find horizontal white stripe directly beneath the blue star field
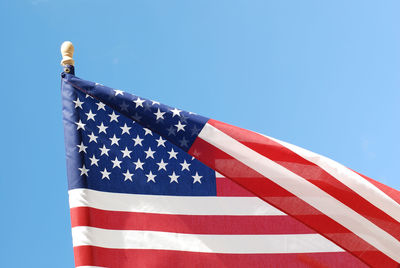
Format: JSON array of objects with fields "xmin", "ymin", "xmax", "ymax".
[{"xmin": 68, "ymin": 189, "xmax": 286, "ymax": 216}]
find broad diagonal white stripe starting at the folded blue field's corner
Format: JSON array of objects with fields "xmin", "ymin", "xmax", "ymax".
[{"xmin": 199, "ymin": 124, "xmax": 400, "ymax": 262}]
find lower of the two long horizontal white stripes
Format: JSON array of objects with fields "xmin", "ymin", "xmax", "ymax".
[{"xmin": 72, "ymin": 226, "xmax": 343, "ymax": 254}]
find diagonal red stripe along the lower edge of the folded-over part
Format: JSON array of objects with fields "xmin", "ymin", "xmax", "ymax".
[{"xmin": 189, "ymin": 133, "xmax": 398, "ymax": 267}]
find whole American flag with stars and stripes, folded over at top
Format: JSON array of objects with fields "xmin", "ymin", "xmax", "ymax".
[{"xmin": 62, "ymin": 66, "xmax": 400, "ymax": 267}]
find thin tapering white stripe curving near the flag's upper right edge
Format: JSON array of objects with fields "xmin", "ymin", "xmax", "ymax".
[{"xmin": 268, "ymin": 137, "xmax": 400, "ymax": 222}]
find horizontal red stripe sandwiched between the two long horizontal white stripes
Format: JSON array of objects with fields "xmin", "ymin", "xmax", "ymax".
[{"xmin": 70, "ymin": 207, "xmax": 315, "ymax": 235}]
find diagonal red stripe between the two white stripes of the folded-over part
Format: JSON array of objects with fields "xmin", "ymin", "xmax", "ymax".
[{"xmin": 209, "ymin": 120, "xmax": 400, "ymax": 241}]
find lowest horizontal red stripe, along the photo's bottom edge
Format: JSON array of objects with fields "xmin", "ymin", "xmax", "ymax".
[{"xmin": 74, "ymin": 246, "xmax": 366, "ymax": 268}]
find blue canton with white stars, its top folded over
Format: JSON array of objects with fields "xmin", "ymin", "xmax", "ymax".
[{"xmin": 62, "ymin": 71, "xmax": 216, "ymax": 196}]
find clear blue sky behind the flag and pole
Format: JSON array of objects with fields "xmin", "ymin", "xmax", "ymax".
[{"xmin": 0, "ymin": 0, "xmax": 400, "ymax": 268}]
